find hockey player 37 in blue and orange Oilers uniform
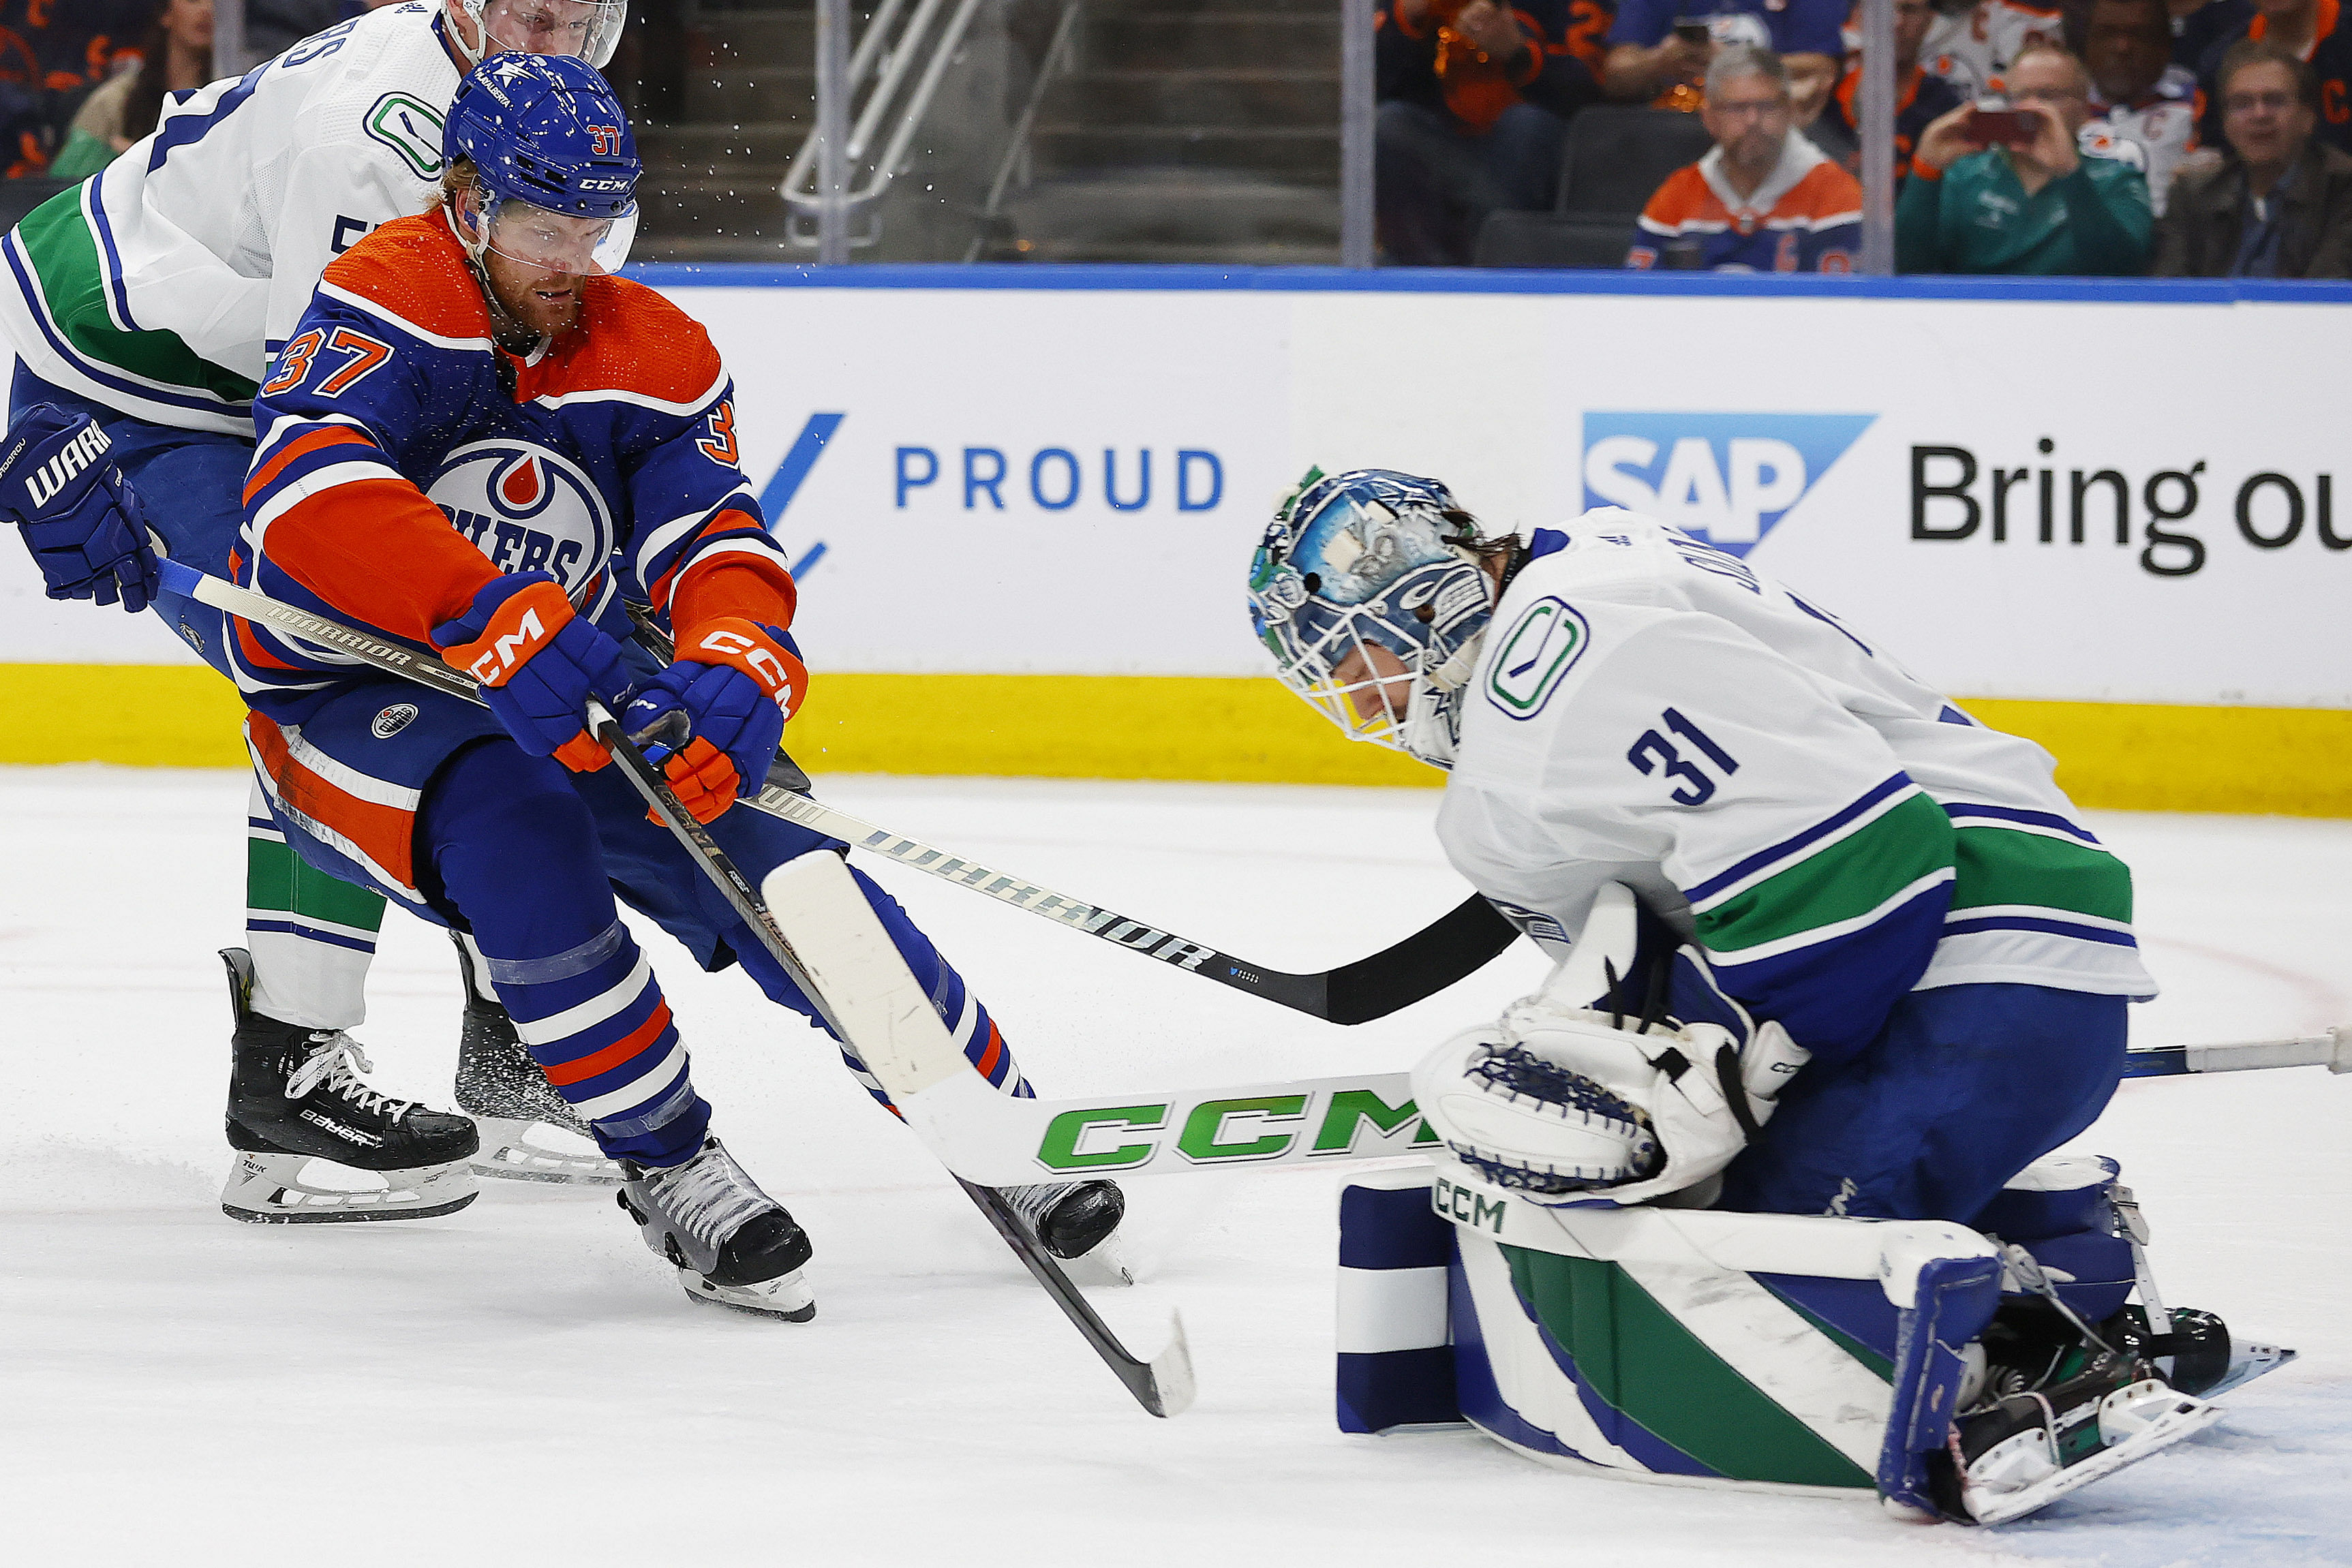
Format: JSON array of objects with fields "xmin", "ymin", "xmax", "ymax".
[{"xmin": 78, "ymin": 57, "xmax": 1122, "ymax": 1319}]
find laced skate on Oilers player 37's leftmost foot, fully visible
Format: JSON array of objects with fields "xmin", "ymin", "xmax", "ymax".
[{"xmin": 614, "ymin": 1138, "xmax": 816, "ymax": 1323}]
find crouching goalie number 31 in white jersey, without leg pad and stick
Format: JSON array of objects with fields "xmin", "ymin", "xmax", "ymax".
[{"xmin": 1249, "ymin": 470, "xmax": 2257, "ymax": 1519}]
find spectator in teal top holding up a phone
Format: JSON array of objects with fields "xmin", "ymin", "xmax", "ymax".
[{"xmin": 1896, "ymin": 45, "xmax": 2154, "ymax": 277}]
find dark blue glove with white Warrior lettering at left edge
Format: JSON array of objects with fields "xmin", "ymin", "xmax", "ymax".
[{"xmin": 0, "ymin": 402, "xmax": 155, "ymax": 613}]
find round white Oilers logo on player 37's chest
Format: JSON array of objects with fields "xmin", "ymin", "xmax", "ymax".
[{"xmin": 423, "ymin": 440, "xmax": 614, "ymax": 604}]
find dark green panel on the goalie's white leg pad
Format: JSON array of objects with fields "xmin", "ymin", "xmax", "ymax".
[{"xmin": 1501, "ymin": 1246, "xmax": 1872, "ymax": 1488}]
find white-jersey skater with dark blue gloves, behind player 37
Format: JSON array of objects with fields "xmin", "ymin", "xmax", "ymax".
[{"xmin": 0, "ymin": 0, "xmax": 626, "ymax": 1220}]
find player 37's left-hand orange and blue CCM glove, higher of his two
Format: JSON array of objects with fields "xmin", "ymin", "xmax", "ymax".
[{"xmin": 433, "ymin": 571, "xmax": 628, "ymax": 773}]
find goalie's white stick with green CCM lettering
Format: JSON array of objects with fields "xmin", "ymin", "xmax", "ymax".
[{"xmin": 885, "ymin": 1025, "xmax": 2352, "ymax": 1185}]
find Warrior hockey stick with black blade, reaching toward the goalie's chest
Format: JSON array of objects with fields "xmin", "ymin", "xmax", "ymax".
[{"xmin": 160, "ymin": 559, "xmax": 1519, "ymax": 1023}]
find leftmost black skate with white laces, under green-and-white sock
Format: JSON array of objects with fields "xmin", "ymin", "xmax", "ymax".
[{"xmin": 221, "ymin": 947, "xmax": 480, "ymax": 1225}]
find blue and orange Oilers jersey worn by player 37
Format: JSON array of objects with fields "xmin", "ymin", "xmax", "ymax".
[{"xmin": 233, "ymin": 211, "xmax": 793, "ymax": 722}]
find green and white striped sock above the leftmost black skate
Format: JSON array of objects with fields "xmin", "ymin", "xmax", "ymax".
[{"xmin": 245, "ymin": 783, "xmax": 384, "ymax": 1030}]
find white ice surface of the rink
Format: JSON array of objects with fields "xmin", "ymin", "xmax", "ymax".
[{"xmin": 0, "ymin": 769, "xmax": 2352, "ymax": 1568}]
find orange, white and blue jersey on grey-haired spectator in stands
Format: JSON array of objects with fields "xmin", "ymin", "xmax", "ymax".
[{"xmin": 1625, "ymin": 132, "xmax": 1863, "ymax": 273}]
